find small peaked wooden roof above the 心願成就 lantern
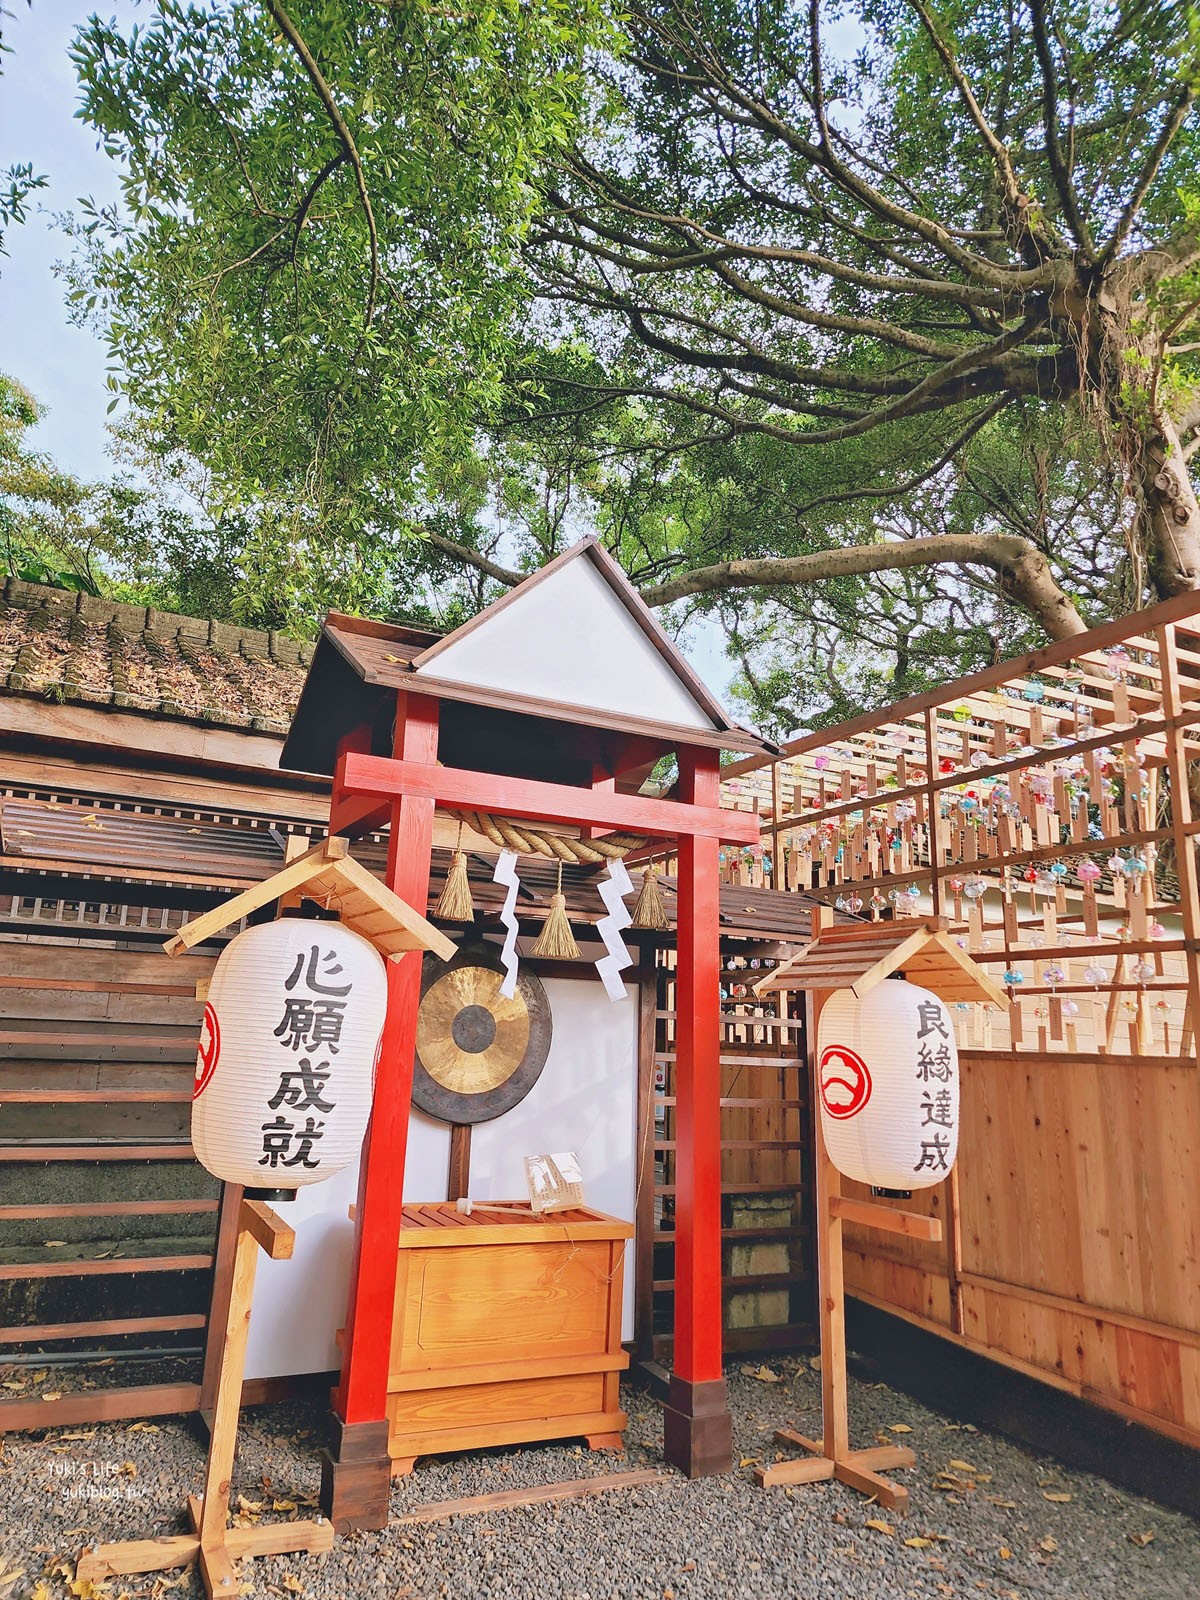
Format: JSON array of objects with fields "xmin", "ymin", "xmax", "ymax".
[{"xmin": 163, "ymin": 838, "xmax": 456, "ymax": 962}]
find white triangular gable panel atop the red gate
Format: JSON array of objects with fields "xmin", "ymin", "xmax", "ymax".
[{"xmin": 414, "ymin": 557, "xmax": 715, "ymax": 731}]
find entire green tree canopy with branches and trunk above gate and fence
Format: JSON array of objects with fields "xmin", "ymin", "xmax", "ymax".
[{"xmin": 49, "ymin": 0, "xmax": 1200, "ymax": 720}]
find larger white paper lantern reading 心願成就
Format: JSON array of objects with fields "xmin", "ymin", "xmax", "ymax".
[{"xmin": 192, "ymin": 917, "xmax": 387, "ymax": 1189}]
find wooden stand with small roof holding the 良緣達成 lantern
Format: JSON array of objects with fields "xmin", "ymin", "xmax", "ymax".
[{"xmin": 754, "ymin": 906, "xmax": 1006, "ymax": 1515}]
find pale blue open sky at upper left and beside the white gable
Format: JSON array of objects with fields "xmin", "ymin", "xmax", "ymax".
[{"xmin": 0, "ymin": 0, "xmax": 733, "ymax": 694}]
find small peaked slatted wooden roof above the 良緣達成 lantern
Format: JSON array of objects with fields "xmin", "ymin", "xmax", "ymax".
[{"xmin": 752, "ymin": 917, "xmax": 1008, "ymax": 1006}]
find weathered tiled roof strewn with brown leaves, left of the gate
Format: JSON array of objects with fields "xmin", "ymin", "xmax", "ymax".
[{"xmin": 0, "ymin": 578, "xmax": 312, "ymax": 734}]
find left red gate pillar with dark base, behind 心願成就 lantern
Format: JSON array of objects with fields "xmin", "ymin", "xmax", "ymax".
[{"xmin": 322, "ymin": 693, "xmax": 438, "ymax": 1531}]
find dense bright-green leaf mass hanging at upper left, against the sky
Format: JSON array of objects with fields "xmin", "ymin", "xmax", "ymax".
[{"xmin": 61, "ymin": 0, "xmax": 614, "ymax": 614}]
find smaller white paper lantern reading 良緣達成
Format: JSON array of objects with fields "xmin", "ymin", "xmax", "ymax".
[{"xmin": 818, "ymin": 978, "xmax": 958, "ymax": 1189}]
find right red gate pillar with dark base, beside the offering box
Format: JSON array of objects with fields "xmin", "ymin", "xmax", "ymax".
[{"xmin": 664, "ymin": 749, "xmax": 733, "ymax": 1478}]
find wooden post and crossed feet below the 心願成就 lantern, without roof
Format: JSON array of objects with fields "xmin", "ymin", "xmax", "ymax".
[{"xmin": 75, "ymin": 1200, "xmax": 333, "ymax": 1600}]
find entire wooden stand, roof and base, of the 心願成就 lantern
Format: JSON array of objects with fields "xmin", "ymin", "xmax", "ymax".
[{"xmin": 75, "ymin": 838, "xmax": 454, "ymax": 1580}]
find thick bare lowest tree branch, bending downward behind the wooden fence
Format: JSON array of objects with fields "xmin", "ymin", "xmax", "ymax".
[{"xmin": 642, "ymin": 533, "xmax": 1086, "ymax": 638}]
